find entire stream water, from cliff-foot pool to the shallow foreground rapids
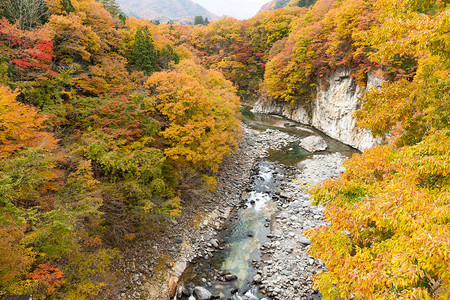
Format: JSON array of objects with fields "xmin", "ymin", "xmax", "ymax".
[{"xmin": 181, "ymin": 111, "xmax": 356, "ymax": 300}]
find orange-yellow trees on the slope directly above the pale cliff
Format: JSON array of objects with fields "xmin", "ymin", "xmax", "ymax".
[{"xmin": 264, "ymin": 0, "xmax": 376, "ymax": 101}]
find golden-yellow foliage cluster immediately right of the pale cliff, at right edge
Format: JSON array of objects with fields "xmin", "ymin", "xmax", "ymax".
[{"xmin": 355, "ymin": 77, "xmax": 444, "ymax": 146}]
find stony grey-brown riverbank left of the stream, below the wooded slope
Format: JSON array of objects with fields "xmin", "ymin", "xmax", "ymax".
[{"xmin": 110, "ymin": 124, "xmax": 304, "ymax": 299}]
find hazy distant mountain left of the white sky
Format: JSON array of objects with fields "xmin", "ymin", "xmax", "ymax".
[{"xmin": 117, "ymin": 0, "xmax": 217, "ymax": 23}]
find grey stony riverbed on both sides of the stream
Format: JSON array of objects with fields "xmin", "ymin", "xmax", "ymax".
[{"xmin": 113, "ymin": 113, "xmax": 352, "ymax": 300}]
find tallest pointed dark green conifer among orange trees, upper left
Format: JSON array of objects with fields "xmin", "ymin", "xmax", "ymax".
[{"xmin": 131, "ymin": 27, "xmax": 158, "ymax": 74}]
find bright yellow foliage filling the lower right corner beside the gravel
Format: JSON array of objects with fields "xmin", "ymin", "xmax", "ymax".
[{"xmin": 308, "ymin": 124, "xmax": 450, "ymax": 299}]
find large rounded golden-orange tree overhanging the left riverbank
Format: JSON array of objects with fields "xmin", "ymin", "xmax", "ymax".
[{"xmin": 147, "ymin": 61, "xmax": 239, "ymax": 171}]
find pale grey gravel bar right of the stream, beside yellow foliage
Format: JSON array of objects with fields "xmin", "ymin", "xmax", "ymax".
[{"xmin": 254, "ymin": 153, "xmax": 345, "ymax": 299}]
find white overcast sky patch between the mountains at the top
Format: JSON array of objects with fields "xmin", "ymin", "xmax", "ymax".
[{"xmin": 193, "ymin": 0, "xmax": 270, "ymax": 19}]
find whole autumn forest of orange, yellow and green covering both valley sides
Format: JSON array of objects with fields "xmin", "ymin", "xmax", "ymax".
[{"xmin": 0, "ymin": 0, "xmax": 450, "ymax": 299}]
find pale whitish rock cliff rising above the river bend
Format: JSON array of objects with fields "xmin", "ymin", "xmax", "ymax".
[{"xmin": 253, "ymin": 69, "xmax": 382, "ymax": 150}]
